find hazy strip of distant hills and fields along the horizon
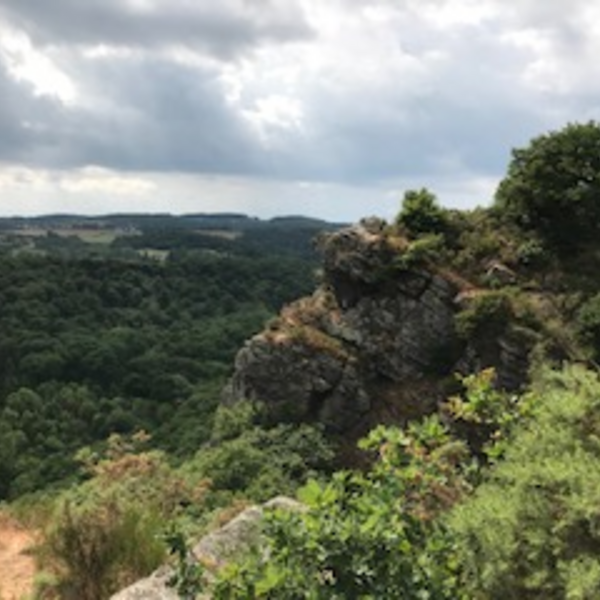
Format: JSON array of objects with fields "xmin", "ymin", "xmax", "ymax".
[{"xmin": 0, "ymin": 213, "xmax": 343, "ymax": 260}]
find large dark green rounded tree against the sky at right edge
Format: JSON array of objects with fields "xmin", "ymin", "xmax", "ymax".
[{"xmin": 496, "ymin": 121, "xmax": 600, "ymax": 249}]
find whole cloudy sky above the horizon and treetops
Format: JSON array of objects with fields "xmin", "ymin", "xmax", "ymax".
[{"xmin": 0, "ymin": 0, "xmax": 600, "ymax": 221}]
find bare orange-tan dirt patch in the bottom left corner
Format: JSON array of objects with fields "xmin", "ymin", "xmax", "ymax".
[{"xmin": 0, "ymin": 515, "xmax": 35, "ymax": 600}]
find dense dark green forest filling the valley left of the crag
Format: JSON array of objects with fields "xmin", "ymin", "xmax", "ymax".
[{"xmin": 0, "ymin": 217, "xmax": 332, "ymax": 498}]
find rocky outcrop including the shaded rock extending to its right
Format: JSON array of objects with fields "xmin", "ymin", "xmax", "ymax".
[{"xmin": 223, "ymin": 221, "xmax": 529, "ymax": 435}]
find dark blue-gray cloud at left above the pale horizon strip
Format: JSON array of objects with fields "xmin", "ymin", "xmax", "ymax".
[{"xmin": 0, "ymin": 41, "xmax": 268, "ymax": 173}]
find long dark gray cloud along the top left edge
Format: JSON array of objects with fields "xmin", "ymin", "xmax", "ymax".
[{"xmin": 0, "ymin": 0, "xmax": 312, "ymax": 58}]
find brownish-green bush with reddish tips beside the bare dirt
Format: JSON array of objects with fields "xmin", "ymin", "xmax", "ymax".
[{"xmin": 39, "ymin": 434, "xmax": 205, "ymax": 600}]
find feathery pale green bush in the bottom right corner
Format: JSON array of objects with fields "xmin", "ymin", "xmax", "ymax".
[{"xmin": 449, "ymin": 367, "xmax": 600, "ymax": 600}]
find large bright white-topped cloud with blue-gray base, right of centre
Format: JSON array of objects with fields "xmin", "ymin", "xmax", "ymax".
[{"xmin": 220, "ymin": 2, "xmax": 543, "ymax": 183}]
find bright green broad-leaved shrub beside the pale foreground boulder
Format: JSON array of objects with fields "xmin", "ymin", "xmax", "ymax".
[{"xmin": 212, "ymin": 419, "xmax": 464, "ymax": 600}]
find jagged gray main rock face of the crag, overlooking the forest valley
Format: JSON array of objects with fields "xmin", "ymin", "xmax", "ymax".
[{"xmin": 224, "ymin": 226, "xmax": 457, "ymax": 433}]
